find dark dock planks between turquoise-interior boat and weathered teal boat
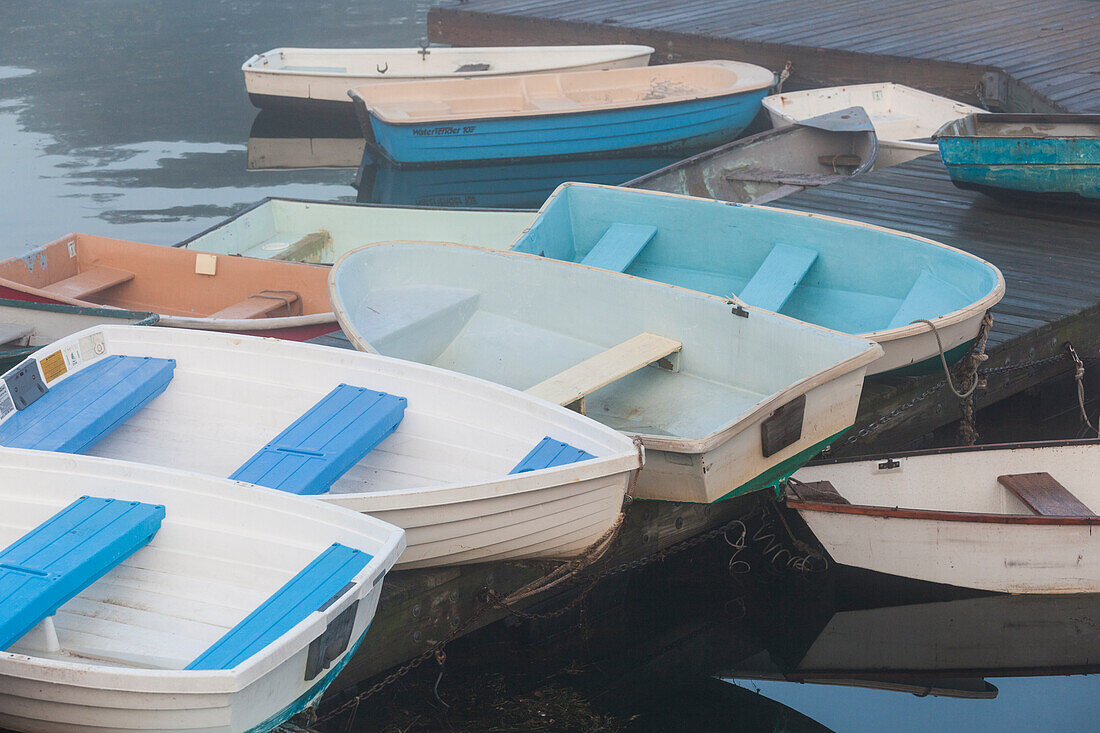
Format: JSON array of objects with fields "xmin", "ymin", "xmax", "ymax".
[{"xmin": 772, "ymin": 155, "xmax": 1100, "ymax": 453}]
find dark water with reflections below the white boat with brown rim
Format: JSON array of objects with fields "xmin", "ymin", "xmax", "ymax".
[{"xmin": 321, "ymin": 515, "xmax": 1100, "ymax": 732}]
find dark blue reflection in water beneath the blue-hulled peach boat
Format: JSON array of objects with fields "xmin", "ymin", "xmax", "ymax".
[{"xmin": 355, "ymin": 149, "xmax": 674, "ymax": 209}]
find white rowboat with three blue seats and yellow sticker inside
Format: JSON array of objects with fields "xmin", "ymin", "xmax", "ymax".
[{"xmin": 0, "ymin": 327, "xmax": 642, "ymax": 568}]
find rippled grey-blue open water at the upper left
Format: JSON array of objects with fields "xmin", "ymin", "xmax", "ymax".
[{"xmin": 0, "ymin": 0, "xmax": 431, "ymax": 256}]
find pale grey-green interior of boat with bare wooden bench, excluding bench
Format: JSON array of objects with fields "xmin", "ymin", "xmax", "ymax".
[{"xmin": 330, "ymin": 242, "xmax": 880, "ymax": 442}]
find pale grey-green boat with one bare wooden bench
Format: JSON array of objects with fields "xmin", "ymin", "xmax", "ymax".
[{"xmin": 330, "ymin": 242, "xmax": 881, "ymax": 502}]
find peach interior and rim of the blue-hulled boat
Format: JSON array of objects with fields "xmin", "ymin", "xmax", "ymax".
[{"xmin": 354, "ymin": 61, "xmax": 774, "ymax": 123}]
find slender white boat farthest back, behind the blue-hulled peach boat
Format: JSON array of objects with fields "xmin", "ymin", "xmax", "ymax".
[{"xmin": 241, "ymin": 45, "xmax": 653, "ymax": 109}]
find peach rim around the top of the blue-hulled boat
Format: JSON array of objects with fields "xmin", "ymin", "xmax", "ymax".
[{"xmin": 348, "ymin": 59, "xmax": 776, "ymax": 125}]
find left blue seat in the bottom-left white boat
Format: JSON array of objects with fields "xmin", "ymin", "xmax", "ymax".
[{"xmin": 0, "ymin": 496, "xmax": 164, "ymax": 649}]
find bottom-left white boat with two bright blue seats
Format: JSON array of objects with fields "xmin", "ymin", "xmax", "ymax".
[{"xmin": 0, "ymin": 449, "xmax": 405, "ymax": 733}]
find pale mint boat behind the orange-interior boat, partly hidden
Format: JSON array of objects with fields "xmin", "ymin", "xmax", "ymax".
[{"xmin": 176, "ymin": 198, "xmax": 535, "ymax": 264}]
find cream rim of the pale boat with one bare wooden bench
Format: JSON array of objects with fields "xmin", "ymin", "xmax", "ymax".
[{"xmin": 329, "ymin": 239, "xmax": 883, "ymax": 453}]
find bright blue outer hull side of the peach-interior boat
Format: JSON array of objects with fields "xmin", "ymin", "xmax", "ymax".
[{"xmin": 358, "ymin": 89, "xmax": 768, "ymax": 164}]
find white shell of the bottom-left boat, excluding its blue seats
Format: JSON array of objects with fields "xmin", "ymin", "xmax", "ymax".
[{"xmin": 0, "ymin": 449, "xmax": 405, "ymax": 733}]
